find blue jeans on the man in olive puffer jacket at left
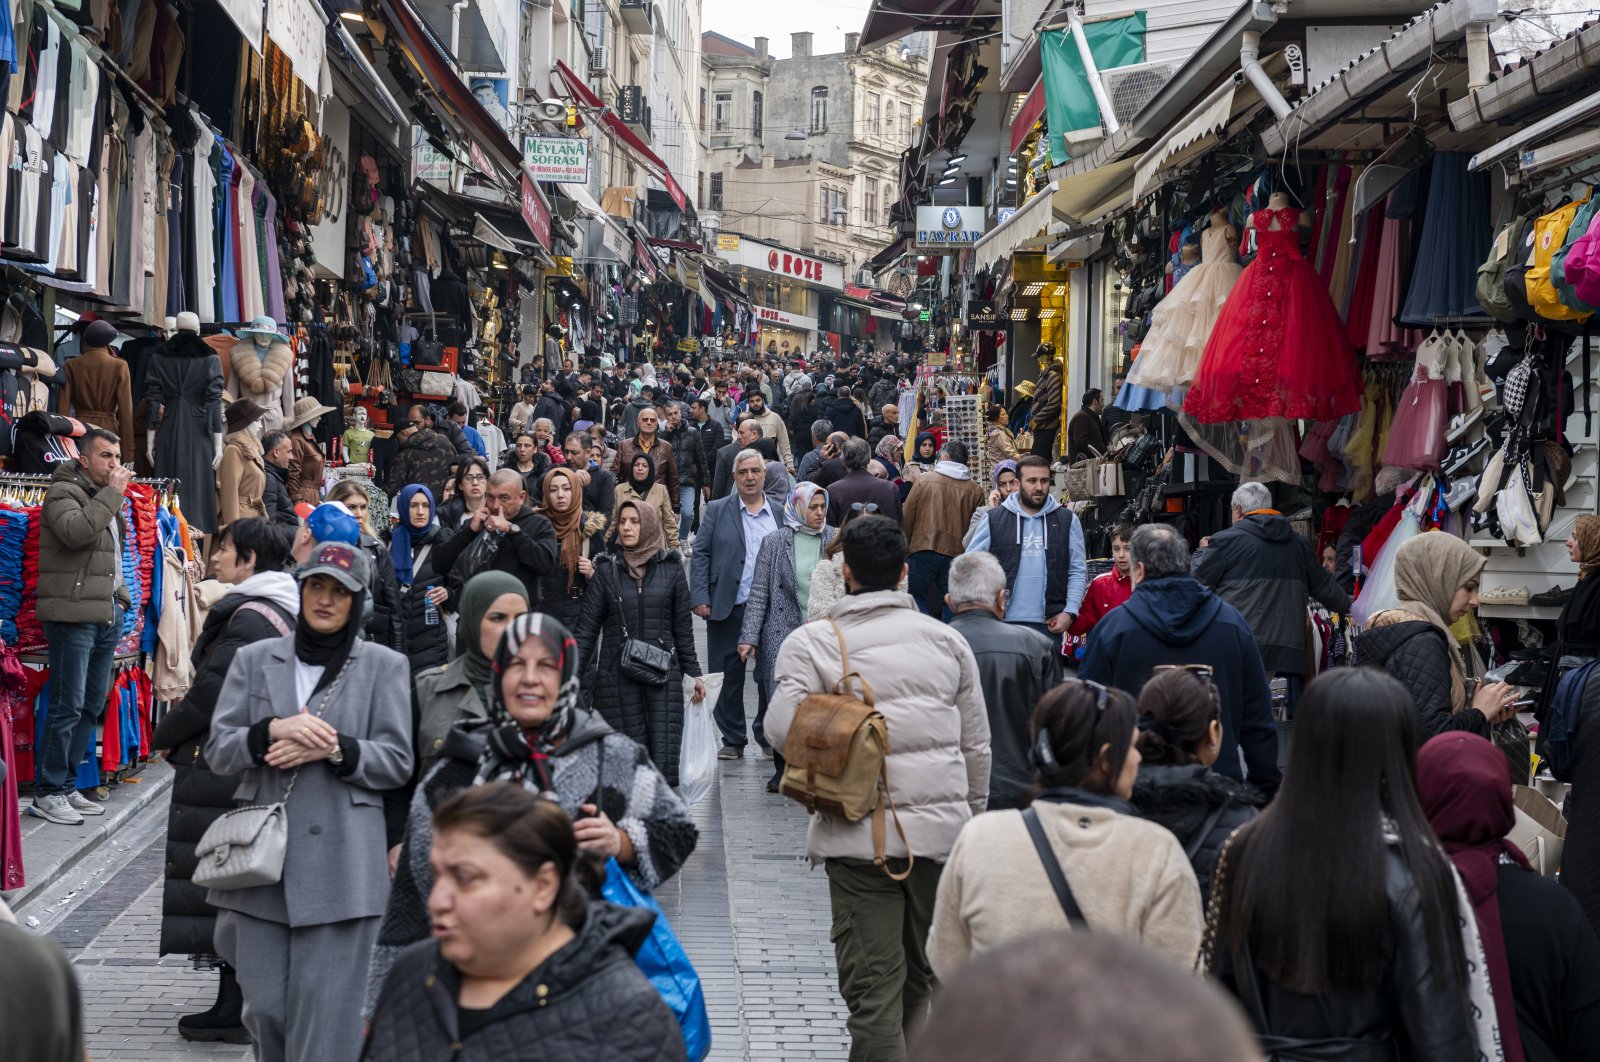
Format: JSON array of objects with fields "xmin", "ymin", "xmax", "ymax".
[{"xmin": 35, "ymin": 608, "xmax": 122, "ymax": 797}]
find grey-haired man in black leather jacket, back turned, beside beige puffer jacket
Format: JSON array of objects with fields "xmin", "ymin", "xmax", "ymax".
[{"xmin": 944, "ymin": 553, "xmax": 1061, "ymax": 811}]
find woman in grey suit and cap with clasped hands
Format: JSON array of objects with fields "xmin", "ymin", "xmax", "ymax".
[{"xmin": 205, "ymin": 542, "xmax": 413, "ymax": 1062}]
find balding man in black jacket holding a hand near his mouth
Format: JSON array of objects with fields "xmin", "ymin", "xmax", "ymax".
[{"xmin": 430, "ymin": 469, "xmax": 560, "ymax": 609}]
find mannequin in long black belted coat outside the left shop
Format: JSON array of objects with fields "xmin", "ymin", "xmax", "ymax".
[{"xmin": 142, "ymin": 312, "xmax": 222, "ymax": 534}]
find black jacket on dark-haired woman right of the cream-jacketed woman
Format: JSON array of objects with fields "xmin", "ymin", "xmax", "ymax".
[{"xmin": 1133, "ymin": 763, "xmax": 1262, "ymax": 904}]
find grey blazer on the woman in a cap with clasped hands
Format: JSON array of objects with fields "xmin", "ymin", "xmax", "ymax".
[{"xmin": 205, "ymin": 635, "xmax": 413, "ymax": 926}]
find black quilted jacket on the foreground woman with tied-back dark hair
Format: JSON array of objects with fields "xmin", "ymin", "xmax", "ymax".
[{"xmin": 362, "ymin": 902, "xmax": 685, "ymax": 1062}]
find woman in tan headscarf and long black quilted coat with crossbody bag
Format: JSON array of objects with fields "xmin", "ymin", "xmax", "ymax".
[{"xmin": 578, "ymin": 501, "xmax": 706, "ymax": 785}]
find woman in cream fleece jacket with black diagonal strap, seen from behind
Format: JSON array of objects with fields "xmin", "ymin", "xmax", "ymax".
[{"xmin": 928, "ymin": 680, "xmax": 1202, "ymax": 979}]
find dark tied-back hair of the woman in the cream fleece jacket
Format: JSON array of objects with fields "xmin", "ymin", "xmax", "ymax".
[{"xmin": 1030, "ymin": 680, "xmax": 1138, "ymax": 795}]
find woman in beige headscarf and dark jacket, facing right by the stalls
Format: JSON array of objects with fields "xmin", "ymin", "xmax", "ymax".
[{"xmin": 1357, "ymin": 531, "xmax": 1517, "ymax": 737}]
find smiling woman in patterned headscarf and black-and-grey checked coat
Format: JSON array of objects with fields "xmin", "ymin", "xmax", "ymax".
[{"xmin": 371, "ymin": 614, "xmax": 698, "ymax": 1010}]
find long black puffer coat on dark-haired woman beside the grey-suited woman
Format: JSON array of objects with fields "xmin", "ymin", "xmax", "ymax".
[{"xmin": 150, "ymin": 576, "xmax": 294, "ymax": 955}]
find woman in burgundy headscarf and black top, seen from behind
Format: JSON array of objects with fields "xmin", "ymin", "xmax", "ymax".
[{"xmin": 1416, "ymin": 733, "xmax": 1600, "ymax": 1062}]
